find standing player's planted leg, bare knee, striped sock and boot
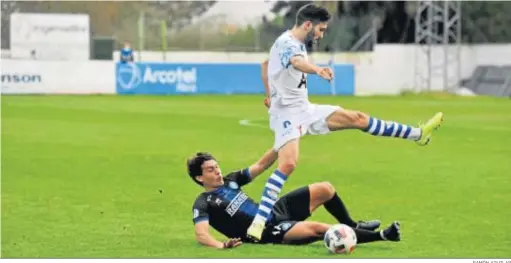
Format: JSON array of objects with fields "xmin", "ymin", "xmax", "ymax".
[{"xmin": 247, "ymin": 139, "xmax": 299, "ymax": 241}]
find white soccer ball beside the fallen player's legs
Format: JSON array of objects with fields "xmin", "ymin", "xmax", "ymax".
[{"xmin": 324, "ymin": 224, "xmax": 357, "ymax": 254}]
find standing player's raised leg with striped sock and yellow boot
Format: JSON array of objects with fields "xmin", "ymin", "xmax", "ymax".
[{"xmin": 327, "ymin": 109, "xmax": 444, "ymax": 145}]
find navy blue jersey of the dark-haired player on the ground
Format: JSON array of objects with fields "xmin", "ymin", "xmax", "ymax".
[{"xmin": 193, "ymin": 169, "xmax": 259, "ymax": 239}]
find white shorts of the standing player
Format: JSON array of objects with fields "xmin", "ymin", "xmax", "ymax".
[{"xmin": 270, "ymin": 104, "xmax": 341, "ymax": 151}]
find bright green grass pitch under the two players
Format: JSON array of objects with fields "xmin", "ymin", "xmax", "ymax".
[{"xmin": 1, "ymin": 96, "xmax": 511, "ymax": 258}]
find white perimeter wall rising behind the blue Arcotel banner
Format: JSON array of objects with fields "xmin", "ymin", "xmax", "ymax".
[{"xmin": 114, "ymin": 44, "xmax": 511, "ymax": 95}]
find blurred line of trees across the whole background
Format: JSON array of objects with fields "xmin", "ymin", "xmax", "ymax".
[{"xmin": 1, "ymin": 1, "xmax": 511, "ymax": 51}]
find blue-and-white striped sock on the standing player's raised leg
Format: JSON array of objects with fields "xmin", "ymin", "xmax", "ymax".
[{"xmin": 364, "ymin": 117, "xmax": 421, "ymax": 141}]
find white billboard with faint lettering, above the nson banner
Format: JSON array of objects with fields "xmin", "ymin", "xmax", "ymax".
[{"xmin": 10, "ymin": 13, "xmax": 90, "ymax": 60}]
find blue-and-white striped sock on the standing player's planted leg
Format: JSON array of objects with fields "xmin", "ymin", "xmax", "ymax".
[{"xmin": 254, "ymin": 170, "xmax": 287, "ymax": 224}]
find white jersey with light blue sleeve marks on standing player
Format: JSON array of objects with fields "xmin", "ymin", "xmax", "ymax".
[{"xmin": 268, "ymin": 31, "xmax": 309, "ymax": 115}]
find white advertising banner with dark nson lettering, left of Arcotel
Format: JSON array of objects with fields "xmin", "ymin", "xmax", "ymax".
[{"xmin": 1, "ymin": 59, "xmax": 115, "ymax": 94}]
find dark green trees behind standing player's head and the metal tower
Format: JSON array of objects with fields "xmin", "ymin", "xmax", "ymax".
[{"xmin": 262, "ymin": 1, "xmax": 511, "ymax": 51}]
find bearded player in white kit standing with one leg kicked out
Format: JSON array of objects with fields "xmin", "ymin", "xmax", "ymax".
[{"xmin": 247, "ymin": 4, "xmax": 443, "ymax": 243}]
